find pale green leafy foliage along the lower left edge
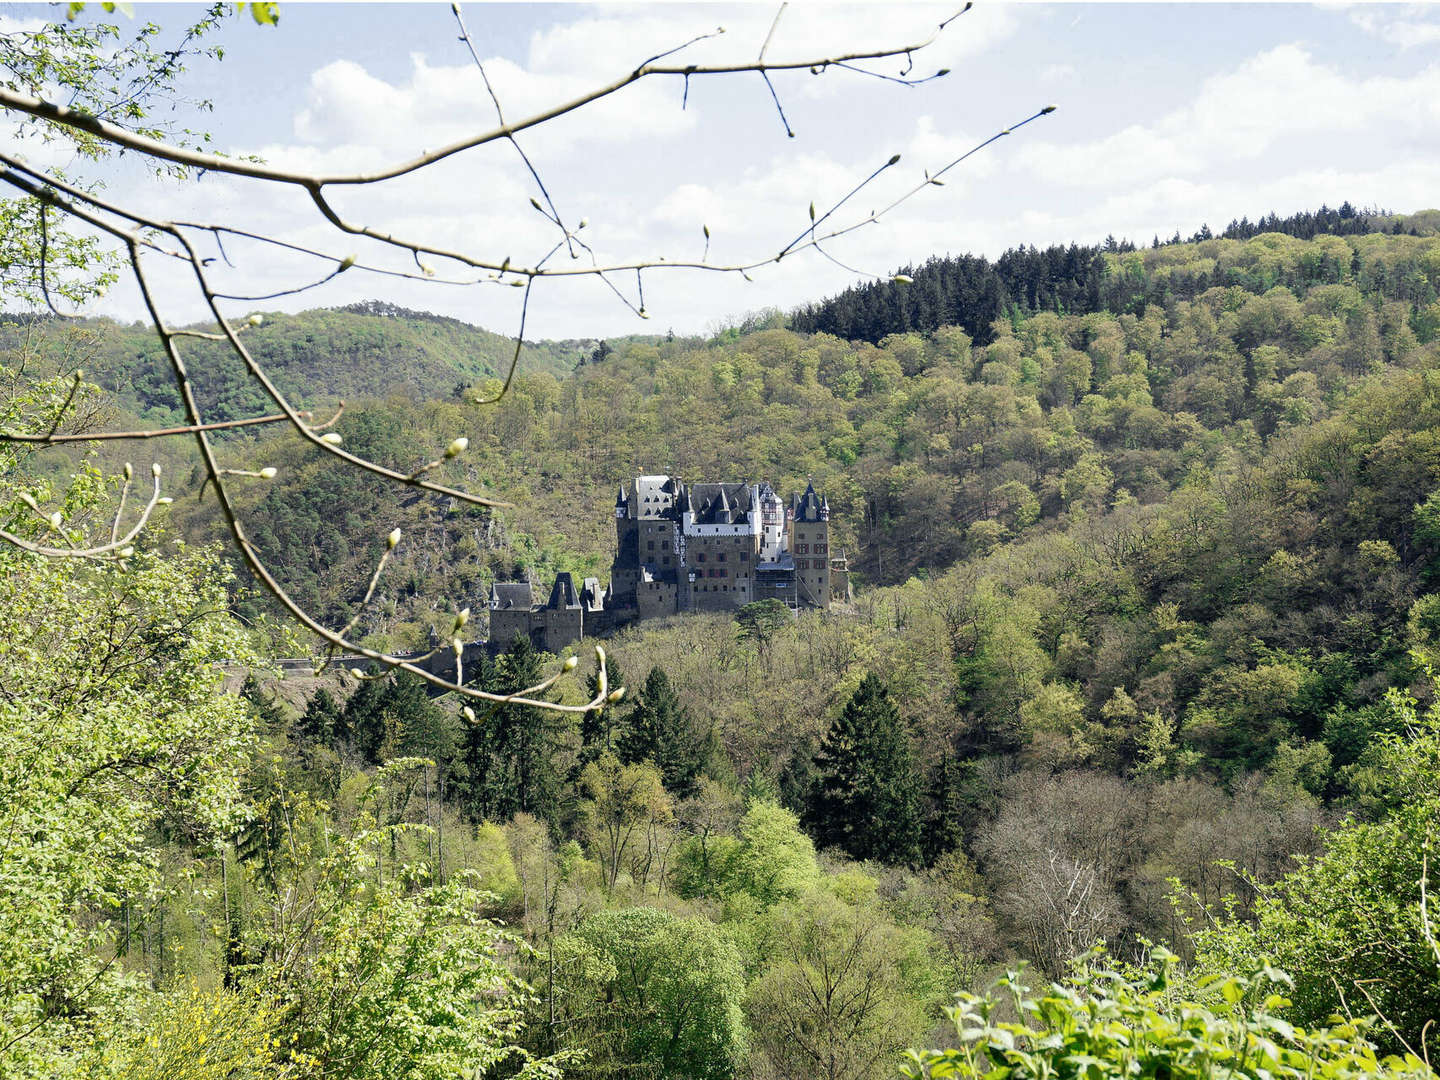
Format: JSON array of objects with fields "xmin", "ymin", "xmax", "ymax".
[{"xmin": 0, "ymin": 552, "xmax": 255, "ymax": 1073}]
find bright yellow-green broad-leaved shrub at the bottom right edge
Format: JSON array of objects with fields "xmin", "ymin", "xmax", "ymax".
[{"xmin": 903, "ymin": 950, "xmax": 1433, "ymax": 1080}]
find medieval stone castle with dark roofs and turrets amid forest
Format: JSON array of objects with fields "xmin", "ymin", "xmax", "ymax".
[{"xmin": 490, "ymin": 475, "xmax": 851, "ymax": 652}]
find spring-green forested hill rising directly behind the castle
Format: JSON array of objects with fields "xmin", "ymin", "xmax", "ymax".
[{"xmin": 95, "ymin": 223, "xmax": 1440, "ymax": 647}]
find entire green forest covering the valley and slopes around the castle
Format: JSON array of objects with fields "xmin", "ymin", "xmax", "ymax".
[{"xmin": 0, "ymin": 194, "xmax": 1440, "ymax": 1080}]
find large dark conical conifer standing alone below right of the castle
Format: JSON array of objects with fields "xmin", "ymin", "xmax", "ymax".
[{"xmin": 806, "ymin": 675, "xmax": 920, "ymax": 863}]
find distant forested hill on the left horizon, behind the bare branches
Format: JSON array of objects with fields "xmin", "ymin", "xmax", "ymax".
[{"xmin": 0, "ymin": 301, "xmax": 595, "ymax": 425}]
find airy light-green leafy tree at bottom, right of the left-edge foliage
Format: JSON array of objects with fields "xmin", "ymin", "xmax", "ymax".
[{"xmin": 243, "ymin": 759, "xmax": 559, "ymax": 1080}]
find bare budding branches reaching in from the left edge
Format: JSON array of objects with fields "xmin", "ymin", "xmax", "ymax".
[{"xmin": 0, "ymin": 4, "xmax": 1053, "ymax": 713}]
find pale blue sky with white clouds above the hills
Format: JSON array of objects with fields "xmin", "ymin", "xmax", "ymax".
[{"xmin": 0, "ymin": 1, "xmax": 1440, "ymax": 338}]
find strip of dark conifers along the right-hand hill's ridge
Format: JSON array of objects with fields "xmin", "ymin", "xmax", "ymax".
[{"xmin": 791, "ymin": 203, "xmax": 1440, "ymax": 344}]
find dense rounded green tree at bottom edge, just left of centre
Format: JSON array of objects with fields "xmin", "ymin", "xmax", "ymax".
[{"xmin": 557, "ymin": 907, "xmax": 746, "ymax": 1080}]
